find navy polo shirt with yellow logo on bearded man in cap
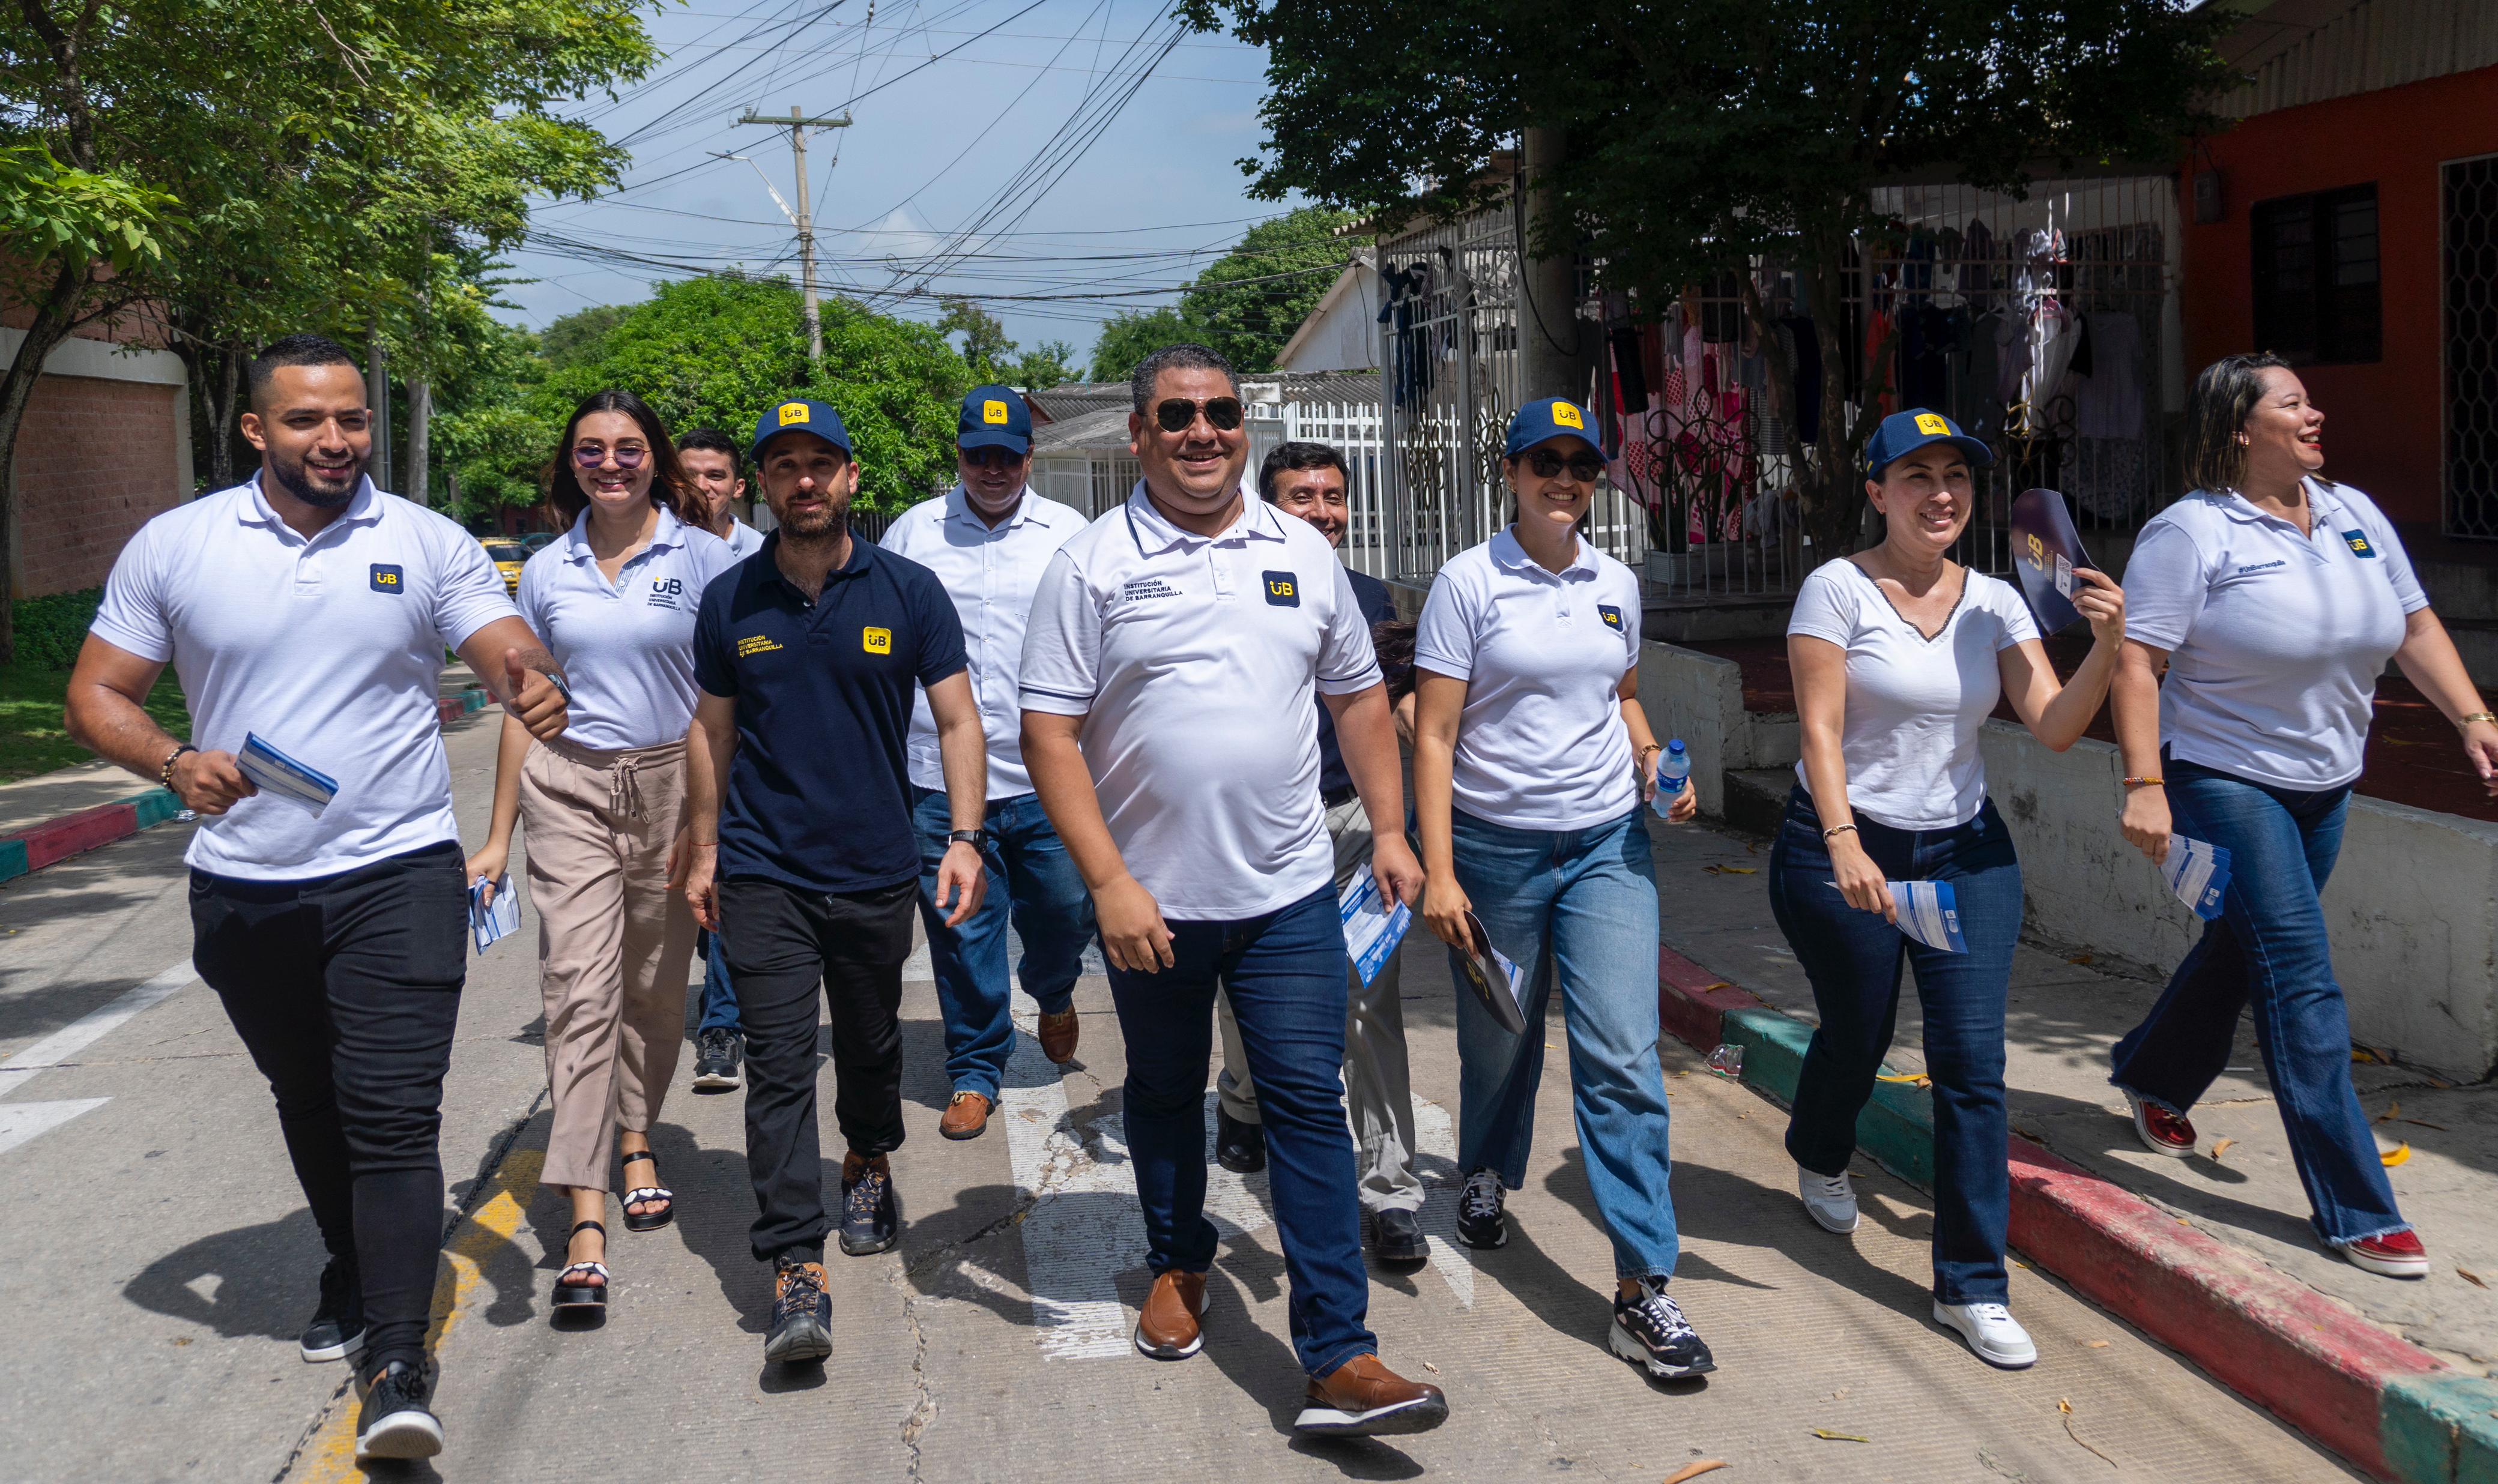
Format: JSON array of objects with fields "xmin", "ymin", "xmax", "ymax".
[{"xmin": 694, "ymin": 532, "xmax": 967, "ymax": 894}]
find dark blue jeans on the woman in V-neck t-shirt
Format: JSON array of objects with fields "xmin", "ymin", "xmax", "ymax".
[{"xmin": 1768, "ymin": 787, "xmax": 2021, "ymax": 1304}]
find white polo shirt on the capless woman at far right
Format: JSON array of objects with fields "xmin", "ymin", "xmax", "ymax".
[{"xmin": 2126, "ymin": 480, "xmax": 2428, "ymax": 789}]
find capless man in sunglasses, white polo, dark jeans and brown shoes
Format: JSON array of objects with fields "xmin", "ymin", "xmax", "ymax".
[{"xmin": 1021, "ymin": 345, "xmax": 1449, "ymax": 1434}]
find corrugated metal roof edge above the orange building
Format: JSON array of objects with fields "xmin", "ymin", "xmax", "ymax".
[{"xmin": 2218, "ymin": 0, "xmax": 2498, "ymax": 118}]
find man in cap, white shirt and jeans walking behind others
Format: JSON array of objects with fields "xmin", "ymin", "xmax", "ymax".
[{"xmin": 885, "ymin": 385, "xmax": 1092, "ymax": 1139}]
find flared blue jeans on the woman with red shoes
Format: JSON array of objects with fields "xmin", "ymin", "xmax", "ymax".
[{"xmin": 2108, "ymin": 759, "xmax": 2410, "ymax": 1241}]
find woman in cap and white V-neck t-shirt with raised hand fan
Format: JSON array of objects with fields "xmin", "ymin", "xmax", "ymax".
[{"xmin": 1768, "ymin": 410, "xmax": 2126, "ymax": 1369}]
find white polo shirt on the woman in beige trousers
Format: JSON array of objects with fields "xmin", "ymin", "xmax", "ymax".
[{"xmin": 519, "ymin": 510, "xmax": 734, "ymax": 752}]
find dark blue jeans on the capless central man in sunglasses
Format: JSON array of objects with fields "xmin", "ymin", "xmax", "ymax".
[{"xmin": 1109, "ymin": 884, "xmax": 1379, "ymax": 1377}]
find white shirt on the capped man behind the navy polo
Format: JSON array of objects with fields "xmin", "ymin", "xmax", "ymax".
[{"xmin": 877, "ymin": 484, "xmax": 1084, "ymax": 800}]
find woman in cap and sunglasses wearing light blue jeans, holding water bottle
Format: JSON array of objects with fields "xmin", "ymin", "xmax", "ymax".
[{"xmin": 1414, "ymin": 397, "xmax": 1716, "ymax": 1379}]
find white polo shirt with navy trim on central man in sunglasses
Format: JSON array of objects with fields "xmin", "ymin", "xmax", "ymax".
[{"xmin": 1021, "ymin": 482, "xmax": 1379, "ymax": 922}]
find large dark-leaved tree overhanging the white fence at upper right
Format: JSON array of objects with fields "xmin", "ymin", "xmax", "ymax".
[{"xmin": 1182, "ymin": 0, "xmax": 2236, "ymax": 552}]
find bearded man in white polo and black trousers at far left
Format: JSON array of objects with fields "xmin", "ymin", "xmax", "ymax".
[{"xmin": 67, "ymin": 335, "xmax": 567, "ymax": 1459}]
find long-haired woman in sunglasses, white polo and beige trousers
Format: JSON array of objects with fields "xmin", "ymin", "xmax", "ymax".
[{"xmin": 467, "ymin": 392, "xmax": 737, "ymax": 1317}]
